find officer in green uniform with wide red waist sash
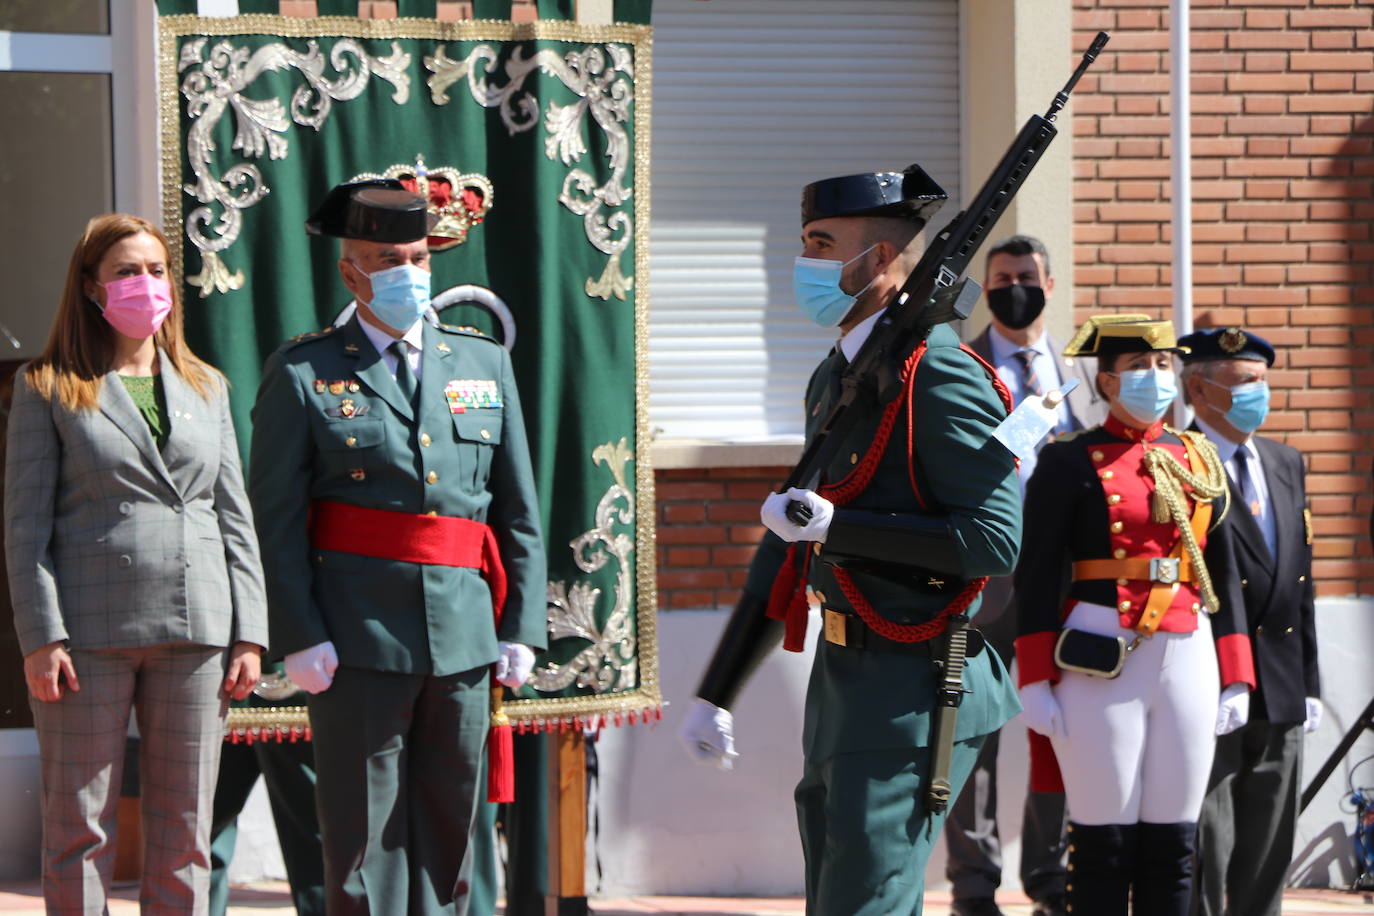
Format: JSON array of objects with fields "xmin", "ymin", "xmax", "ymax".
[{"xmin": 249, "ymin": 180, "xmax": 547, "ymax": 916}]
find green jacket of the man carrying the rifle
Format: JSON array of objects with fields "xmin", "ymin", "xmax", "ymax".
[{"xmin": 745, "ymin": 324, "xmax": 1021, "ymax": 762}]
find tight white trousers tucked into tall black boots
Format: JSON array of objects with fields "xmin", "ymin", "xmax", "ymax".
[{"xmin": 1054, "ymin": 603, "xmax": 1221, "ymax": 825}]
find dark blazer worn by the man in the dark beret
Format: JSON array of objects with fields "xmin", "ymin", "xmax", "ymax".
[{"xmin": 1231, "ymin": 435, "xmax": 1322, "ymax": 722}]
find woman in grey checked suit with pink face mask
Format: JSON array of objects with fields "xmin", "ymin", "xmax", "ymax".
[{"xmin": 4, "ymin": 214, "xmax": 267, "ymax": 915}]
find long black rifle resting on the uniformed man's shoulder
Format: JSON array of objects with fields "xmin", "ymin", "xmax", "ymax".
[{"xmin": 782, "ymin": 32, "xmax": 1110, "ymax": 526}]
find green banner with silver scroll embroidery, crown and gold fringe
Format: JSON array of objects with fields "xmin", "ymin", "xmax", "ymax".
[{"xmin": 159, "ymin": 10, "xmax": 661, "ymax": 729}]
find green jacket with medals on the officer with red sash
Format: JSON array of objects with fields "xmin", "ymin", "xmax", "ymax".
[{"xmin": 249, "ymin": 317, "xmax": 547, "ymax": 676}]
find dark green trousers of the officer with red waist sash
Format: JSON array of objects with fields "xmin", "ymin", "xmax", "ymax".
[{"xmin": 309, "ymin": 665, "xmax": 491, "ymax": 916}]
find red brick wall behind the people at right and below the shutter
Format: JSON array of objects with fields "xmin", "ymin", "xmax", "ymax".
[{"xmin": 658, "ymin": 0, "xmax": 1374, "ymax": 608}]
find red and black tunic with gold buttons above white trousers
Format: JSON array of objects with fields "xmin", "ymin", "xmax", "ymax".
[{"xmin": 1015, "ymin": 416, "xmax": 1254, "ymax": 791}]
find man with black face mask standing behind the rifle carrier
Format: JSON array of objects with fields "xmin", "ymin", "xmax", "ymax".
[{"xmin": 945, "ymin": 235, "xmax": 1106, "ymax": 916}]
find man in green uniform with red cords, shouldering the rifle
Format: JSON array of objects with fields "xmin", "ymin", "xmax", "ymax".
[{"xmin": 683, "ymin": 166, "xmax": 1021, "ymax": 916}]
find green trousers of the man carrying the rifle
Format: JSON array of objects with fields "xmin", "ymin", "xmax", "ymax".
[{"xmin": 796, "ymin": 735, "xmax": 987, "ymax": 916}]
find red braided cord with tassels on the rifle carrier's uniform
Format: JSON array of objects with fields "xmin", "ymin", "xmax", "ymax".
[{"xmin": 768, "ymin": 341, "xmax": 1011, "ymax": 652}]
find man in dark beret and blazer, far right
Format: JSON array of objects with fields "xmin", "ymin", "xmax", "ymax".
[{"xmin": 1179, "ymin": 327, "xmax": 1322, "ymax": 916}]
